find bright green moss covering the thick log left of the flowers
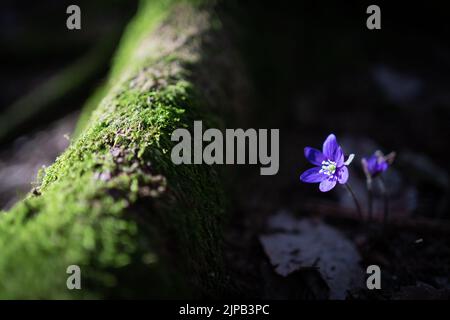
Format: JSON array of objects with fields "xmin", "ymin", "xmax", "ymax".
[{"xmin": 0, "ymin": 1, "xmax": 224, "ymax": 299}]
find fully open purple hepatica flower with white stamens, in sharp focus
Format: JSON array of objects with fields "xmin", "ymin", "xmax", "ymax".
[{"xmin": 300, "ymin": 134, "xmax": 354, "ymax": 192}]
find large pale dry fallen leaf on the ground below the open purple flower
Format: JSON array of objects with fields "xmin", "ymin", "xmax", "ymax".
[{"xmin": 260, "ymin": 211, "xmax": 363, "ymax": 300}]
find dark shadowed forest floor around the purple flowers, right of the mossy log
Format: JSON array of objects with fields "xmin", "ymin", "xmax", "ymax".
[{"xmin": 221, "ymin": 4, "xmax": 450, "ymax": 299}]
